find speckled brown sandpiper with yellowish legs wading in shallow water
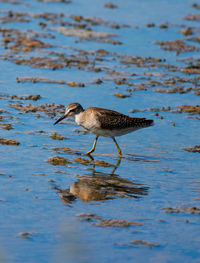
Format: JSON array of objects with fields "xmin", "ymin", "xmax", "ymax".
[{"xmin": 54, "ymin": 103, "xmax": 153, "ymax": 156}]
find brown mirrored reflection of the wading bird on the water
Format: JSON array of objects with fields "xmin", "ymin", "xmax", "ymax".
[{"xmin": 54, "ymin": 158, "xmax": 149, "ymax": 204}]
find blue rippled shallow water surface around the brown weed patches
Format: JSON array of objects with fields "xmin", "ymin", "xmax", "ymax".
[{"xmin": 0, "ymin": 0, "xmax": 200, "ymax": 263}]
